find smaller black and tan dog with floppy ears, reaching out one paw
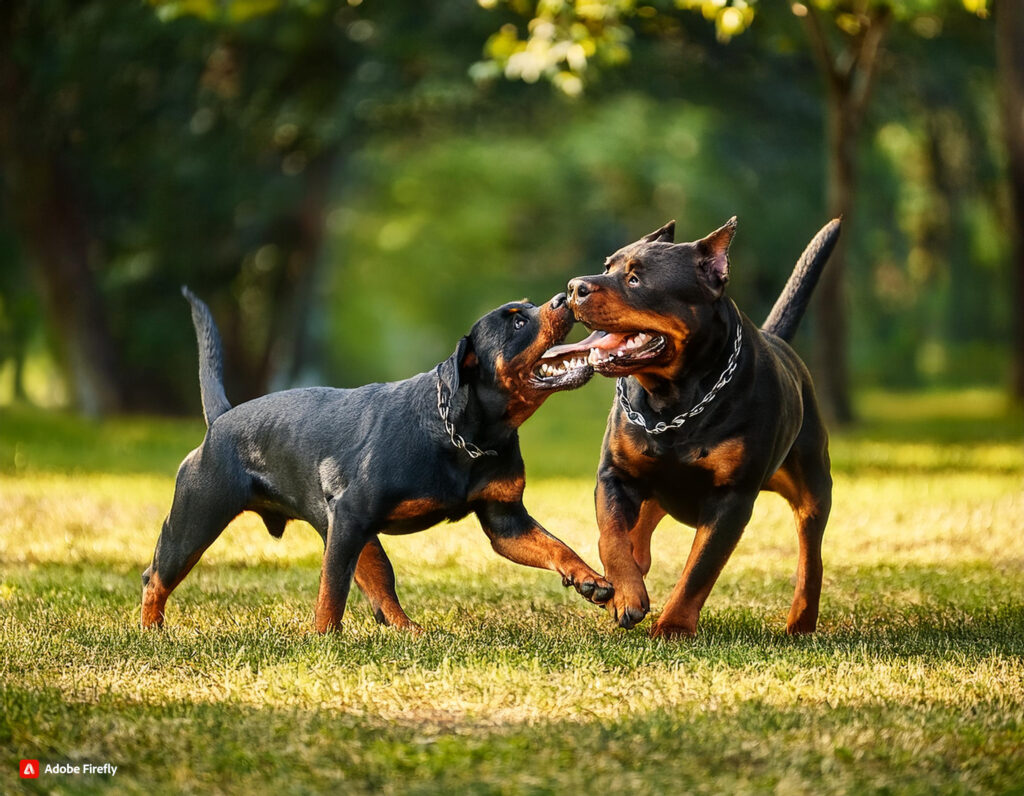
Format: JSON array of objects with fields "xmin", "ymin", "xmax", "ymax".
[{"xmin": 141, "ymin": 288, "xmax": 614, "ymax": 633}]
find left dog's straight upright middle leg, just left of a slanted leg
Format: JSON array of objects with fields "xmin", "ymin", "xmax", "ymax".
[{"xmin": 315, "ymin": 500, "xmax": 373, "ymax": 633}]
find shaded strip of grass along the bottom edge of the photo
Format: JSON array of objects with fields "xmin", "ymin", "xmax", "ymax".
[{"xmin": 6, "ymin": 683, "xmax": 1024, "ymax": 794}]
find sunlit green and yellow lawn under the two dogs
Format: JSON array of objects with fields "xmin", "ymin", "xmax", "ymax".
[{"xmin": 0, "ymin": 382, "xmax": 1024, "ymax": 794}]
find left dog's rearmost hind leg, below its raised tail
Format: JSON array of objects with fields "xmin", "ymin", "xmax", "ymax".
[{"xmin": 142, "ymin": 452, "xmax": 245, "ymax": 628}]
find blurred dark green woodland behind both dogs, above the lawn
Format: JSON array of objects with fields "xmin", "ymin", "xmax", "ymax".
[{"xmin": 0, "ymin": 0, "xmax": 1011, "ymax": 418}]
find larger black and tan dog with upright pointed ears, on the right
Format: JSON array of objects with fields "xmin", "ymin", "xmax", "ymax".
[{"xmin": 549, "ymin": 218, "xmax": 840, "ymax": 636}]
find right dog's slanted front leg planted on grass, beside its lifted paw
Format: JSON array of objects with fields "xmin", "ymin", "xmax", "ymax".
[{"xmin": 650, "ymin": 491, "xmax": 756, "ymax": 638}]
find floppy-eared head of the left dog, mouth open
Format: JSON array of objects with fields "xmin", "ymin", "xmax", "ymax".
[{"xmin": 441, "ymin": 293, "xmax": 594, "ymax": 428}]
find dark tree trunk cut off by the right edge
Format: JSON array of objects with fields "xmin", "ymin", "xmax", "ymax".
[{"xmin": 995, "ymin": 0, "xmax": 1024, "ymax": 400}]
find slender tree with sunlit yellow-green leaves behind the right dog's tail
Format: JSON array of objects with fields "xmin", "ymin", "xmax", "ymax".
[{"xmin": 481, "ymin": 0, "xmax": 987, "ymax": 423}]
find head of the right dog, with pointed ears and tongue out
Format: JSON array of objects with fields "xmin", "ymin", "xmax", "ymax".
[{"xmin": 554, "ymin": 217, "xmax": 736, "ymax": 379}]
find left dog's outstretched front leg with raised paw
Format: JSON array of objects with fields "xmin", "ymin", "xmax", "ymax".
[{"xmin": 476, "ymin": 501, "xmax": 614, "ymax": 604}]
